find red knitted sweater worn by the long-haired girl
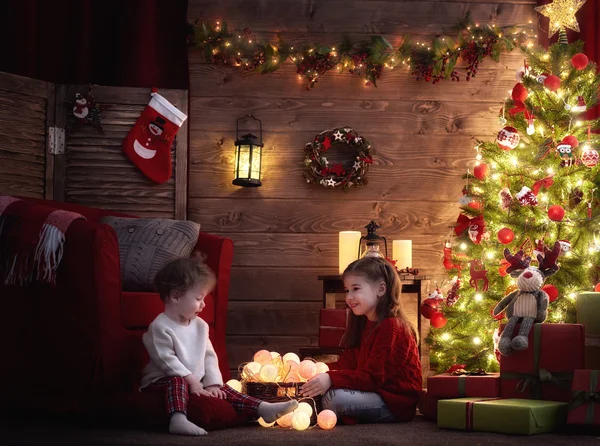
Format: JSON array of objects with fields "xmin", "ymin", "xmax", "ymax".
[{"xmin": 328, "ymin": 318, "xmax": 422, "ymax": 421}]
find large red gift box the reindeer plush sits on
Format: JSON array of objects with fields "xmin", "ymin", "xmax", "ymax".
[{"xmin": 500, "ymin": 324, "xmax": 584, "ymax": 401}]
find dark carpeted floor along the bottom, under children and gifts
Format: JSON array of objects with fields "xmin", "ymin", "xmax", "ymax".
[{"xmin": 0, "ymin": 416, "xmax": 600, "ymax": 446}]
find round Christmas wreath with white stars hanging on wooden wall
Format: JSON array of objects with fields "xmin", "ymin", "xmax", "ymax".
[{"xmin": 304, "ymin": 127, "xmax": 373, "ymax": 190}]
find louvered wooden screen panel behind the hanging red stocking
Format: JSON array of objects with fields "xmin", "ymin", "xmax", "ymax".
[{"xmin": 61, "ymin": 85, "xmax": 188, "ymax": 219}]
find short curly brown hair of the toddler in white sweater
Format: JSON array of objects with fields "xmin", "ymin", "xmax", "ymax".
[{"xmin": 154, "ymin": 253, "xmax": 217, "ymax": 302}]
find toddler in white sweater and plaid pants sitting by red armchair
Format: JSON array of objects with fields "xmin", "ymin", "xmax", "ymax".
[{"xmin": 140, "ymin": 257, "xmax": 298, "ymax": 435}]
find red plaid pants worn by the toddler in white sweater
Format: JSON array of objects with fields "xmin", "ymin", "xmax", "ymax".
[{"xmin": 142, "ymin": 376, "xmax": 262, "ymax": 416}]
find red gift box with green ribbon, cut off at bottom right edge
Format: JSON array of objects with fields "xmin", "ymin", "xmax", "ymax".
[{"xmin": 567, "ymin": 370, "xmax": 600, "ymax": 426}]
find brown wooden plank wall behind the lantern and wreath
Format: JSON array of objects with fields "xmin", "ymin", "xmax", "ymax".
[{"xmin": 188, "ymin": 0, "xmax": 535, "ymax": 375}]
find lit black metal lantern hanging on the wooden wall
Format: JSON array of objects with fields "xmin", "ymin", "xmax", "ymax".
[{"xmin": 233, "ymin": 115, "xmax": 264, "ymax": 187}]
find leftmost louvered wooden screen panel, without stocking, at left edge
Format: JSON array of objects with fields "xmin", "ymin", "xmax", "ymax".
[{"xmin": 0, "ymin": 73, "xmax": 53, "ymax": 198}]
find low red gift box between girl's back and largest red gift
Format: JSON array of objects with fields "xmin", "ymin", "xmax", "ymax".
[{"xmin": 423, "ymin": 373, "xmax": 500, "ymax": 420}]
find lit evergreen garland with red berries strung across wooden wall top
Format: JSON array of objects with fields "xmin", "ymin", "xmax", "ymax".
[{"xmin": 187, "ymin": 14, "xmax": 533, "ymax": 90}]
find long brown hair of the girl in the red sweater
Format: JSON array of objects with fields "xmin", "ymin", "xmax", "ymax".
[{"xmin": 342, "ymin": 257, "xmax": 418, "ymax": 348}]
